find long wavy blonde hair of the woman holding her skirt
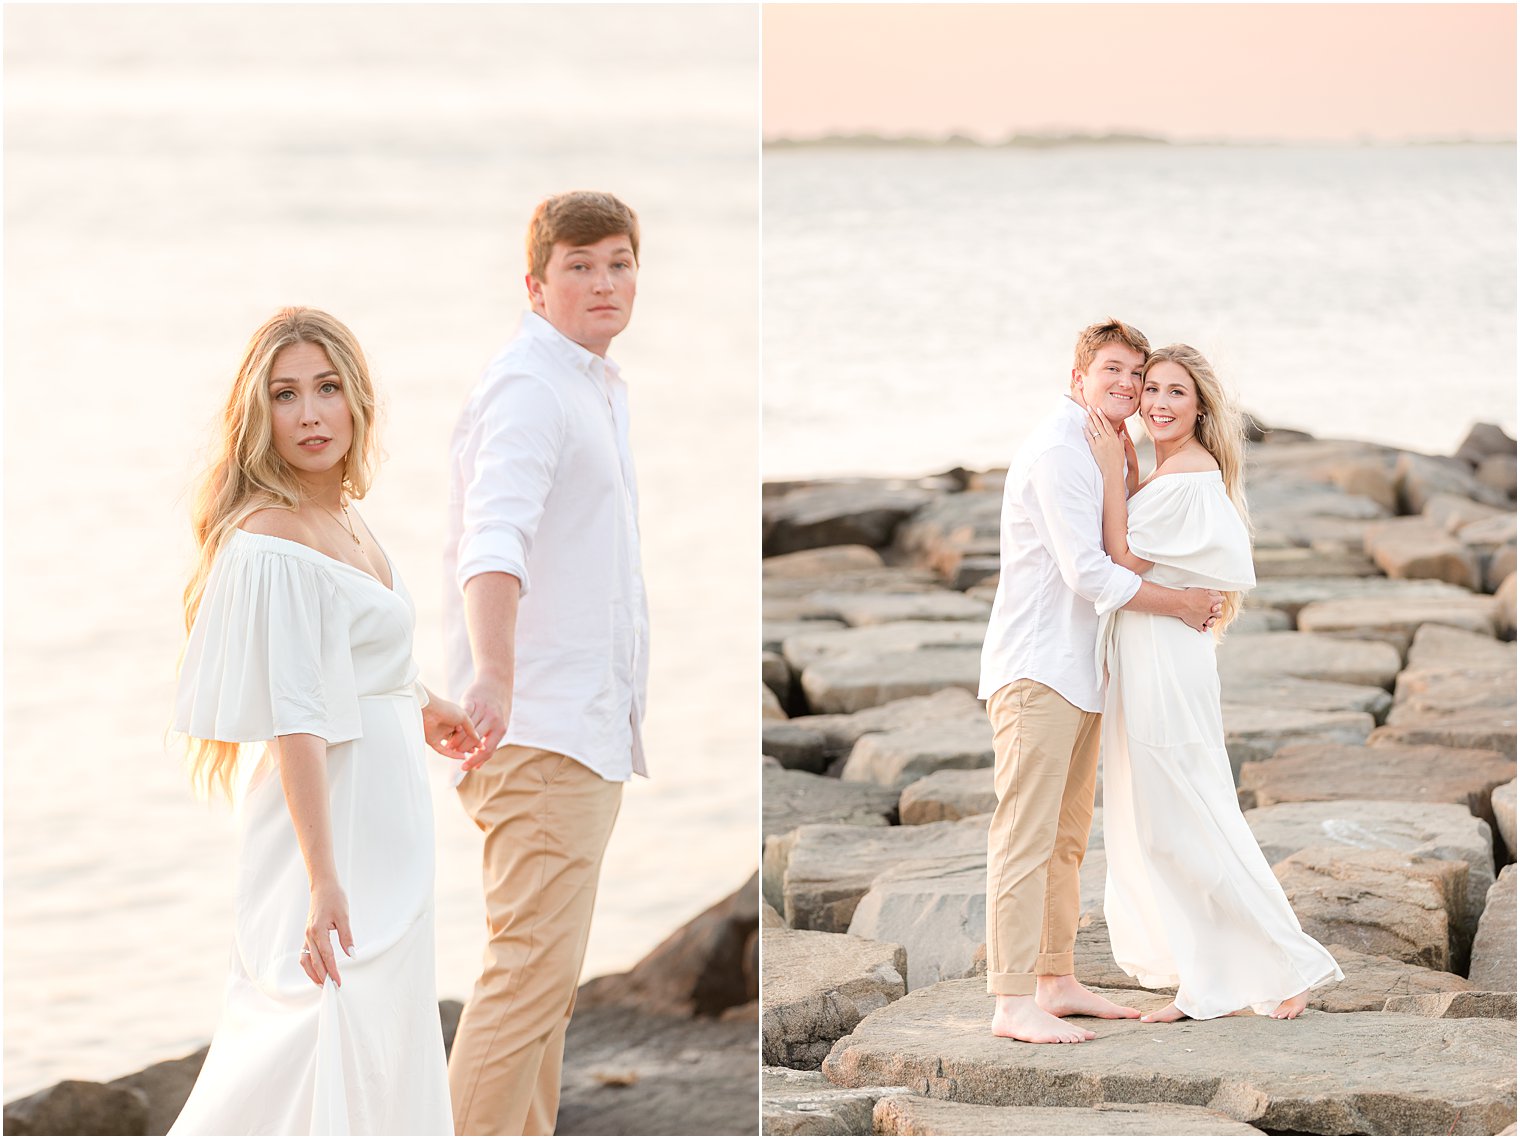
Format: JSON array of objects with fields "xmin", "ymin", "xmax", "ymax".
[{"xmin": 181, "ymin": 307, "xmax": 378, "ymax": 797}]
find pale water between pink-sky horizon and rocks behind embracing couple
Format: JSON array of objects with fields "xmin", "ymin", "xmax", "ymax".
[{"xmin": 762, "ymin": 144, "xmax": 1515, "ymax": 477}]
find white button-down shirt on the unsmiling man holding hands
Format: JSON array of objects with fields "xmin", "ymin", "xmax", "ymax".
[{"xmin": 444, "ymin": 313, "xmax": 649, "ymax": 782}]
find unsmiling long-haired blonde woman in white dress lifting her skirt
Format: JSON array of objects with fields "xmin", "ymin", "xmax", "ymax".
[{"xmin": 170, "ymin": 309, "xmax": 483, "ymax": 1134}]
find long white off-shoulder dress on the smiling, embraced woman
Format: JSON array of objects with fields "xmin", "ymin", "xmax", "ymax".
[{"xmin": 1099, "ymin": 471, "xmax": 1342, "ymax": 1020}]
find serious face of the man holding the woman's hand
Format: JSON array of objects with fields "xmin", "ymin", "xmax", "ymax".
[{"xmin": 527, "ymin": 234, "xmax": 638, "ymax": 356}]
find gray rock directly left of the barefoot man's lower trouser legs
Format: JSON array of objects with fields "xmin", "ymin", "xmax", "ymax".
[{"xmin": 850, "ymin": 846, "xmax": 986, "ymax": 990}]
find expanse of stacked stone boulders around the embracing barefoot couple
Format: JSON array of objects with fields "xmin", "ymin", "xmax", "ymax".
[{"xmin": 760, "ymin": 424, "xmax": 1515, "ymax": 1134}]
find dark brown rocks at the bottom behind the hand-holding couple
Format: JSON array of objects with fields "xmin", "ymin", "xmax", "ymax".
[{"xmin": 5, "ymin": 876, "xmax": 760, "ymax": 1134}]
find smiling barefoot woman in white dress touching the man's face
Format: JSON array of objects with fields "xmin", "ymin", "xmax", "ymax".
[{"xmin": 1087, "ymin": 344, "xmax": 1342, "ymax": 1020}]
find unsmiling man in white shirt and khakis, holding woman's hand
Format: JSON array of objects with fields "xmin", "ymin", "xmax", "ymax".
[{"xmin": 444, "ymin": 192, "xmax": 649, "ymax": 1134}]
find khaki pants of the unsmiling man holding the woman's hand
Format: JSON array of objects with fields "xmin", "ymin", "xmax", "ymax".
[{"xmin": 448, "ymin": 745, "xmax": 623, "ymax": 1134}]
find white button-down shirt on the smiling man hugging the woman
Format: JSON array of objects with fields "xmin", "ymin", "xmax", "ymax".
[{"xmin": 977, "ymin": 398, "xmax": 1140, "ymax": 712}]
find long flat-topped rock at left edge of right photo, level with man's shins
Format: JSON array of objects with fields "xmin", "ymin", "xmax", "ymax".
[{"xmin": 765, "ymin": 817, "xmax": 988, "ymax": 934}]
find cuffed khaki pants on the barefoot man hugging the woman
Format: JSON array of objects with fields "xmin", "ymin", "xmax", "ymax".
[{"xmin": 986, "ymin": 680, "xmax": 1102, "ymax": 996}]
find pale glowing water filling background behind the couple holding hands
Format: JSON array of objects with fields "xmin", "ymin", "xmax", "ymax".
[{"xmin": 3, "ymin": 5, "xmax": 758, "ymax": 1099}]
